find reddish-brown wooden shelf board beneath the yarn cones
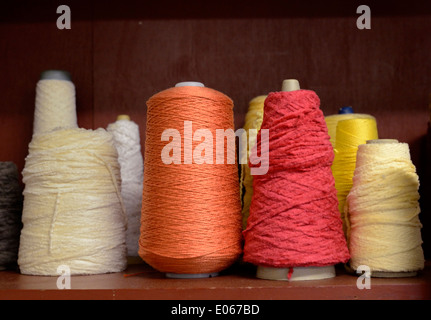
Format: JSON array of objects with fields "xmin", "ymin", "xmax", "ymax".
[{"xmin": 0, "ymin": 263, "xmax": 431, "ymax": 300}]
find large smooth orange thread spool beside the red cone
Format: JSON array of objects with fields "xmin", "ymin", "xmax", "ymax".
[{"xmin": 139, "ymin": 82, "xmax": 245, "ymax": 278}]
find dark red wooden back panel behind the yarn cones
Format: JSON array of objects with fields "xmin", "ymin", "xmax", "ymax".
[{"xmin": 0, "ymin": 0, "xmax": 431, "ymax": 256}]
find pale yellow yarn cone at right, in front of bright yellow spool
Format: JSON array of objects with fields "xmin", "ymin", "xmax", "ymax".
[{"xmin": 347, "ymin": 139, "xmax": 424, "ymax": 277}]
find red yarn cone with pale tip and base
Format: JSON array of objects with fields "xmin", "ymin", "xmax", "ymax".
[{"xmin": 243, "ymin": 79, "xmax": 350, "ymax": 281}]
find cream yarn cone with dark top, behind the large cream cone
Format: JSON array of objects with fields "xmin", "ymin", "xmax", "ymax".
[{"xmin": 33, "ymin": 70, "xmax": 78, "ymax": 133}]
